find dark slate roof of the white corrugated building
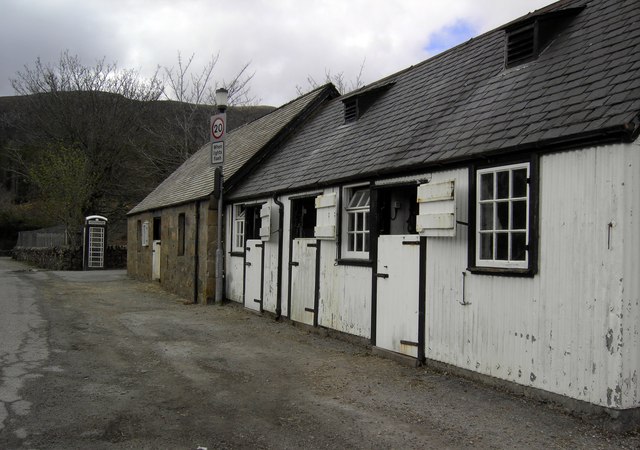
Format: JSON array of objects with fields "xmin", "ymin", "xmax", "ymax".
[{"xmin": 227, "ymin": 0, "xmax": 640, "ymax": 199}]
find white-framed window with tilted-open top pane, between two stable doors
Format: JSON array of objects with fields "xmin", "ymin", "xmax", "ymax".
[{"xmin": 342, "ymin": 186, "xmax": 370, "ymax": 258}]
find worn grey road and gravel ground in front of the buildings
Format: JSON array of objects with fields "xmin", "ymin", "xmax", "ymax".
[{"xmin": 0, "ymin": 258, "xmax": 640, "ymax": 449}]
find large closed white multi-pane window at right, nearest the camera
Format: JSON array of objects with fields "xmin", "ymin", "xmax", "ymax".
[{"xmin": 475, "ymin": 163, "xmax": 531, "ymax": 269}]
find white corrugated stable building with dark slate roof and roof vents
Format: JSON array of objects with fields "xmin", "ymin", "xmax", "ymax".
[{"xmin": 225, "ymin": 0, "xmax": 640, "ymax": 421}]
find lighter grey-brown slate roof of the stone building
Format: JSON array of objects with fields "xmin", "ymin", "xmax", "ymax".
[{"xmin": 128, "ymin": 85, "xmax": 335, "ymax": 214}]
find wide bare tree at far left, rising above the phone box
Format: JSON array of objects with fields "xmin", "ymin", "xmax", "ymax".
[{"xmin": 11, "ymin": 51, "xmax": 163, "ymax": 232}]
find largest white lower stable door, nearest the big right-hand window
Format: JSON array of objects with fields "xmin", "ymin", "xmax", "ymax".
[{"xmin": 376, "ymin": 235, "xmax": 420, "ymax": 358}]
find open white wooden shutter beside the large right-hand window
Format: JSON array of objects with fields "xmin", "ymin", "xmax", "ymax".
[{"xmin": 416, "ymin": 180, "xmax": 456, "ymax": 237}]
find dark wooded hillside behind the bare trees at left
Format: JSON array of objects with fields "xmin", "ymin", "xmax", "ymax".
[{"xmin": 0, "ymin": 92, "xmax": 274, "ymax": 251}]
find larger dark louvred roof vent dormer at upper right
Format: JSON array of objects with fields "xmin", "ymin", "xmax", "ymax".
[{"xmin": 504, "ymin": 7, "xmax": 584, "ymax": 68}]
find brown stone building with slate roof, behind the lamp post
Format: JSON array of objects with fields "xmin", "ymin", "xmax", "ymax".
[{"xmin": 127, "ymin": 85, "xmax": 338, "ymax": 303}]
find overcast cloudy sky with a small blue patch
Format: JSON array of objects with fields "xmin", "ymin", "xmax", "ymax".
[{"xmin": 0, "ymin": 0, "xmax": 552, "ymax": 106}]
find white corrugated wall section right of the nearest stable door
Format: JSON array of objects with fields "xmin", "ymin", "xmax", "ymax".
[{"xmin": 426, "ymin": 145, "xmax": 640, "ymax": 409}]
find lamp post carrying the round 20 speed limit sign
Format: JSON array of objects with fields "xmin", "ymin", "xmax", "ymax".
[{"xmin": 211, "ymin": 88, "xmax": 229, "ymax": 305}]
